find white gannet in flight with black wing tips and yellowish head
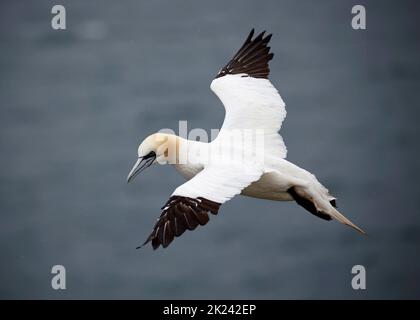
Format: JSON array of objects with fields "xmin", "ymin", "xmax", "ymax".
[{"xmin": 127, "ymin": 30, "xmax": 364, "ymax": 249}]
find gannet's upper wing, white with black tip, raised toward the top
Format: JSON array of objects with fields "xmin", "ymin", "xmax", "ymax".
[{"xmin": 210, "ymin": 30, "xmax": 287, "ymax": 158}]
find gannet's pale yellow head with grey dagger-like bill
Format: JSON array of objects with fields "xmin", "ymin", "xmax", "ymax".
[{"xmin": 127, "ymin": 133, "xmax": 178, "ymax": 183}]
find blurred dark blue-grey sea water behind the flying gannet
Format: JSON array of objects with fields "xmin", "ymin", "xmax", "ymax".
[{"xmin": 0, "ymin": 0, "xmax": 420, "ymax": 299}]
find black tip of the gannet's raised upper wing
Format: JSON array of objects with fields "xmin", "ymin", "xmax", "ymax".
[{"xmin": 216, "ymin": 28, "xmax": 274, "ymax": 79}]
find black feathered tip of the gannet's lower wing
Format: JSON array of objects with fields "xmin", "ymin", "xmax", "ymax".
[{"xmin": 137, "ymin": 196, "xmax": 221, "ymax": 250}]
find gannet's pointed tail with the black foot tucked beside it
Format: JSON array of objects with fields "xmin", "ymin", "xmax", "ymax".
[{"xmin": 288, "ymin": 186, "xmax": 366, "ymax": 234}]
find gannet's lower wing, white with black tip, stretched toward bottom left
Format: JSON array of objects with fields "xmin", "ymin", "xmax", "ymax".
[{"xmin": 143, "ymin": 165, "xmax": 262, "ymax": 249}]
